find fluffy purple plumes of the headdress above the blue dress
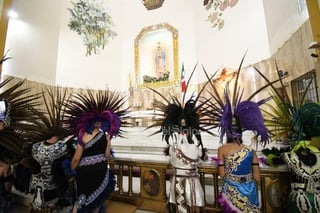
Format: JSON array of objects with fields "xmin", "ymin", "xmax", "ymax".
[{"xmin": 220, "ymin": 85, "xmax": 271, "ymax": 145}]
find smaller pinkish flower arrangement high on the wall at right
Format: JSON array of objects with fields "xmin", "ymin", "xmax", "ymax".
[{"xmin": 203, "ymin": 0, "xmax": 238, "ymax": 30}]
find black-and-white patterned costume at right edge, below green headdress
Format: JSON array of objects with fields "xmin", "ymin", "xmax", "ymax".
[{"xmin": 283, "ymin": 148, "xmax": 320, "ymax": 213}]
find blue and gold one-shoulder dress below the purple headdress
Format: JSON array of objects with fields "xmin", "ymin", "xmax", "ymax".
[{"xmin": 218, "ymin": 146, "xmax": 260, "ymax": 212}]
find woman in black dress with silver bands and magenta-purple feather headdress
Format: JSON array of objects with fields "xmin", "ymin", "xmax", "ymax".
[{"xmin": 67, "ymin": 90, "xmax": 126, "ymax": 213}]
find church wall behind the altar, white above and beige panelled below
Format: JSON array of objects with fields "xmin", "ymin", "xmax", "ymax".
[{"xmin": 2, "ymin": 0, "xmax": 315, "ymax": 123}]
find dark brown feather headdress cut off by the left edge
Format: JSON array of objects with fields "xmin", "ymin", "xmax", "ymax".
[{"xmin": 0, "ymin": 77, "xmax": 39, "ymax": 158}]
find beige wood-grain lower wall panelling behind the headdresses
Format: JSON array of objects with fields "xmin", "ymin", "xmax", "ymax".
[{"xmin": 5, "ymin": 16, "xmax": 315, "ymax": 126}]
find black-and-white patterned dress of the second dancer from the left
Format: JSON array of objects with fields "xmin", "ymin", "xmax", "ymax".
[{"xmin": 30, "ymin": 141, "xmax": 67, "ymax": 209}]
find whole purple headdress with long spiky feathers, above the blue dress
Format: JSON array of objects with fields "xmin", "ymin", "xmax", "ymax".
[{"xmin": 203, "ymin": 54, "xmax": 271, "ymax": 145}]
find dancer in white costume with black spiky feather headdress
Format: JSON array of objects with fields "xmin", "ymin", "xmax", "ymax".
[{"xmin": 149, "ymin": 64, "xmax": 214, "ymax": 213}]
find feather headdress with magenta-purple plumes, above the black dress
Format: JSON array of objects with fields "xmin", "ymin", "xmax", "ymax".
[{"xmin": 66, "ymin": 89, "xmax": 127, "ymax": 144}]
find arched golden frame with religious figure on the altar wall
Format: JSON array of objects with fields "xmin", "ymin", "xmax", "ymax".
[{"xmin": 134, "ymin": 23, "xmax": 179, "ymax": 88}]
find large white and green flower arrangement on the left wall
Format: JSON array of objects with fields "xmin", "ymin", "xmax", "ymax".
[{"xmin": 68, "ymin": 0, "xmax": 117, "ymax": 55}]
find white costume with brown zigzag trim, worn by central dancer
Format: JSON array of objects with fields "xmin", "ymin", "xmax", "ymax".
[{"xmin": 169, "ymin": 135, "xmax": 205, "ymax": 213}]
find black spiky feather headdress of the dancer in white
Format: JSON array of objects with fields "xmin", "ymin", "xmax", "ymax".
[{"xmin": 148, "ymin": 63, "xmax": 214, "ymax": 154}]
